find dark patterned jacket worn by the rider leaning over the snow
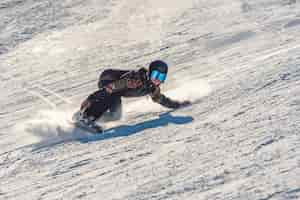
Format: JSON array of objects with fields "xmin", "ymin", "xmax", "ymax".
[{"xmin": 98, "ymin": 68, "xmax": 181, "ymax": 108}]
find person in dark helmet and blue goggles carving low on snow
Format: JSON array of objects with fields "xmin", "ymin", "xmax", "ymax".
[{"xmin": 74, "ymin": 60, "xmax": 190, "ymax": 131}]
